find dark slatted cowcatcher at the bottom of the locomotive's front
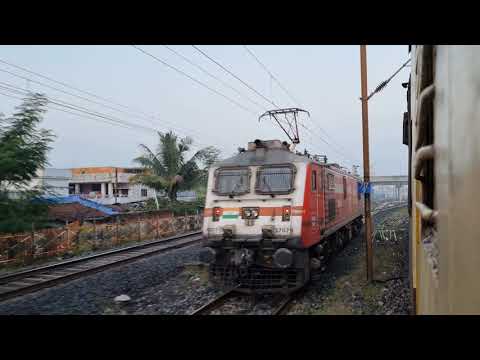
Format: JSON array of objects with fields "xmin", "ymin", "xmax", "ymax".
[{"xmin": 210, "ymin": 265, "xmax": 305, "ymax": 292}]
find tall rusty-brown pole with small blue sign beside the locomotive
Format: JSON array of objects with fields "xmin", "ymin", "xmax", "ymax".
[{"xmin": 360, "ymin": 45, "xmax": 373, "ymax": 282}]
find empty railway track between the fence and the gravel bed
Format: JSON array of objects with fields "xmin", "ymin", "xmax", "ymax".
[{"xmin": 0, "ymin": 231, "xmax": 202, "ymax": 301}]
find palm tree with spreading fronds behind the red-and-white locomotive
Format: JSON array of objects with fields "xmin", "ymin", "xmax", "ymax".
[{"xmin": 131, "ymin": 131, "xmax": 220, "ymax": 201}]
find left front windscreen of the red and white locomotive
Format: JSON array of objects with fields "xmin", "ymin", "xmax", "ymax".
[{"xmin": 214, "ymin": 168, "xmax": 250, "ymax": 195}]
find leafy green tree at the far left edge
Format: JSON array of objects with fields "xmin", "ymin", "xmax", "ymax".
[{"xmin": 0, "ymin": 94, "xmax": 54, "ymax": 232}]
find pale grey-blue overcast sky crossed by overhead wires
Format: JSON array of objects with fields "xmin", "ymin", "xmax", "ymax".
[{"xmin": 0, "ymin": 45, "xmax": 410, "ymax": 175}]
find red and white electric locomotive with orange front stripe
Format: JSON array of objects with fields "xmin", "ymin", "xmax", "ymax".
[{"xmin": 201, "ymin": 140, "xmax": 363, "ymax": 293}]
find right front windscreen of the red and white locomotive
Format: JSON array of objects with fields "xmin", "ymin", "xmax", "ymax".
[{"xmin": 255, "ymin": 164, "xmax": 295, "ymax": 195}]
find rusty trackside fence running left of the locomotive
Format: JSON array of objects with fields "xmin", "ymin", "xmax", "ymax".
[{"xmin": 0, "ymin": 212, "xmax": 203, "ymax": 267}]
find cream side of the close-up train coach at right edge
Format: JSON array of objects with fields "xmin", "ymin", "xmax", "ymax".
[{"xmin": 403, "ymin": 45, "xmax": 480, "ymax": 314}]
